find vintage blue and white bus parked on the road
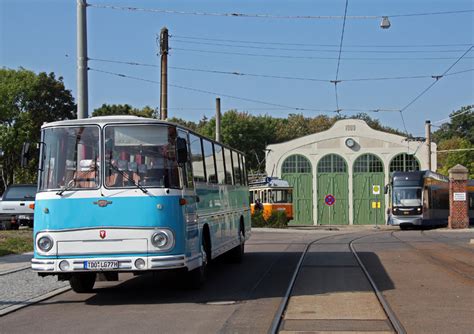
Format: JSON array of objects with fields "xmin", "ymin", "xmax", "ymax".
[{"xmin": 32, "ymin": 116, "xmax": 251, "ymax": 293}]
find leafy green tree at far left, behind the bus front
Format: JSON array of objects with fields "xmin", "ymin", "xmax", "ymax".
[{"xmin": 0, "ymin": 68, "xmax": 76, "ymax": 190}]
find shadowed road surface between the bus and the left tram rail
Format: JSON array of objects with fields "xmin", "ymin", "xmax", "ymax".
[{"xmin": 0, "ymin": 232, "xmax": 316, "ymax": 333}]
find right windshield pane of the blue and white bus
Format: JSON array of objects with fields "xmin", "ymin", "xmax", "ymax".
[{"xmin": 105, "ymin": 125, "xmax": 180, "ymax": 188}]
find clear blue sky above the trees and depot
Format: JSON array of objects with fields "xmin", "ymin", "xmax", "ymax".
[{"xmin": 0, "ymin": 0, "xmax": 474, "ymax": 136}]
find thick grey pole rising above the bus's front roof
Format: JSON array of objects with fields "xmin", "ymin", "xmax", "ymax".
[{"xmin": 76, "ymin": 0, "xmax": 89, "ymax": 119}]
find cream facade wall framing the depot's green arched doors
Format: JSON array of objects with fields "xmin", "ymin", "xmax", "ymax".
[{"xmin": 265, "ymin": 119, "xmax": 437, "ymax": 224}]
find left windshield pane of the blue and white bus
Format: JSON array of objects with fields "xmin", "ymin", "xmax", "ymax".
[{"xmin": 39, "ymin": 126, "xmax": 100, "ymax": 190}]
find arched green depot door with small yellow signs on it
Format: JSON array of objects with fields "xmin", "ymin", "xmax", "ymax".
[{"xmin": 352, "ymin": 154, "xmax": 385, "ymax": 225}]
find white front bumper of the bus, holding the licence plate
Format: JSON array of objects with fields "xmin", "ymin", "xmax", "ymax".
[{"xmin": 31, "ymin": 255, "xmax": 202, "ymax": 274}]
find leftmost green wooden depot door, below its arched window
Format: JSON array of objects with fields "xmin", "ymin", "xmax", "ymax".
[{"xmin": 282, "ymin": 173, "xmax": 313, "ymax": 225}]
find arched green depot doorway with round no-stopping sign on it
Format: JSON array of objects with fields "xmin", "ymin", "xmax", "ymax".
[{"xmin": 317, "ymin": 154, "xmax": 349, "ymax": 225}]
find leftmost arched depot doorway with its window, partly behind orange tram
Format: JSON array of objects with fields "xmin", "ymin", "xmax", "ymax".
[{"xmin": 281, "ymin": 154, "xmax": 313, "ymax": 225}]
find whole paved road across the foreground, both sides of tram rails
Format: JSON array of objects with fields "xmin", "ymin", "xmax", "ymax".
[{"xmin": 0, "ymin": 228, "xmax": 474, "ymax": 333}]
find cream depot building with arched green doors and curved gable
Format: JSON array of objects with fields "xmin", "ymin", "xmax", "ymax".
[{"xmin": 265, "ymin": 119, "xmax": 436, "ymax": 225}]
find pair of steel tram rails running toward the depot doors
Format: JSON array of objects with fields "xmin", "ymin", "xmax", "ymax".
[{"xmin": 269, "ymin": 231, "xmax": 406, "ymax": 334}]
